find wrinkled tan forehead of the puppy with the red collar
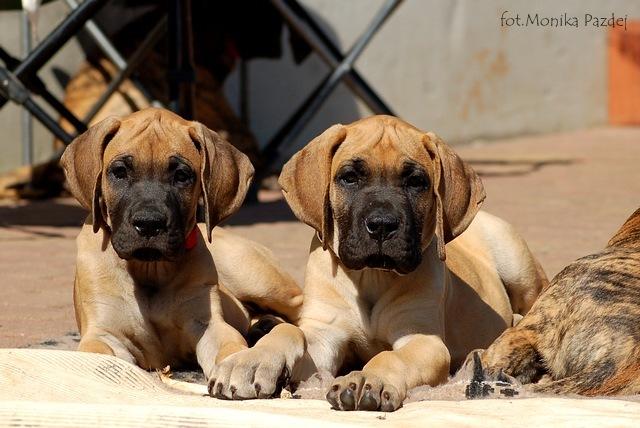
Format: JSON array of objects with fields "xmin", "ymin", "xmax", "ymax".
[{"xmin": 103, "ymin": 115, "xmax": 200, "ymax": 167}]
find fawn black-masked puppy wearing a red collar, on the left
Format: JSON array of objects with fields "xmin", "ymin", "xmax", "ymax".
[{"xmin": 61, "ymin": 109, "xmax": 302, "ymax": 377}]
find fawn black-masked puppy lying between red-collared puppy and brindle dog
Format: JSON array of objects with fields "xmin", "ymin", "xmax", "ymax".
[{"xmin": 210, "ymin": 116, "xmax": 547, "ymax": 411}]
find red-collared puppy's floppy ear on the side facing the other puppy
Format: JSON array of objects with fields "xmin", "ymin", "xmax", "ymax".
[{"xmin": 189, "ymin": 122, "xmax": 254, "ymax": 242}]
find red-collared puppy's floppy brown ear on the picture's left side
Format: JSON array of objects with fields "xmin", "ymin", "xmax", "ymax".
[{"xmin": 60, "ymin": 116, "xmax": 120, "ymax": 233}]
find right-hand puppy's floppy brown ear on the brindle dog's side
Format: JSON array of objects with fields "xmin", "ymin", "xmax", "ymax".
[{"xmin": 424, "ymin": 132, "xmax": 486, "ymax": 261}]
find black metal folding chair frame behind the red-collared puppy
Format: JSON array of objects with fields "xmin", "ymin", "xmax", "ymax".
[{"xmin": 0, "ymin": 0, "xmax": 190, "ymax": 162}]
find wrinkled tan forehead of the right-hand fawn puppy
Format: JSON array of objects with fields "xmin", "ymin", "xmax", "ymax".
[{"xmin": 331, "ymin": 121, "xmax": 432, "ymax": 174}]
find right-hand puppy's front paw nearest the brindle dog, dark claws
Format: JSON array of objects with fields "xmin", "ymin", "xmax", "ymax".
[{"xmin": 327, "ymin": 371, "xmax": 404, "ymax": 412}]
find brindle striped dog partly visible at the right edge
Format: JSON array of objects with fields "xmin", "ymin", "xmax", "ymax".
[{"xmin": 469, "ymin": 209, "xmax": 640, "ymax": 395}]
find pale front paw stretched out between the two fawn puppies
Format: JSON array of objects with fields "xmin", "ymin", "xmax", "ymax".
[{"xmin": 209, "ymin": 346, "xmax": 292, "ymax": 400}]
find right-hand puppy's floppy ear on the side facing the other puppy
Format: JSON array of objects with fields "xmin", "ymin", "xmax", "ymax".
[{"xmin": 278, "ymin": 125, "xmax": 347, "ymax": 249}]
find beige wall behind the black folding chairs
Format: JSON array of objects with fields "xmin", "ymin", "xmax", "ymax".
[{"xmin": 0, "ymin": 0, "xmax": 640, "ymax": 171}]
